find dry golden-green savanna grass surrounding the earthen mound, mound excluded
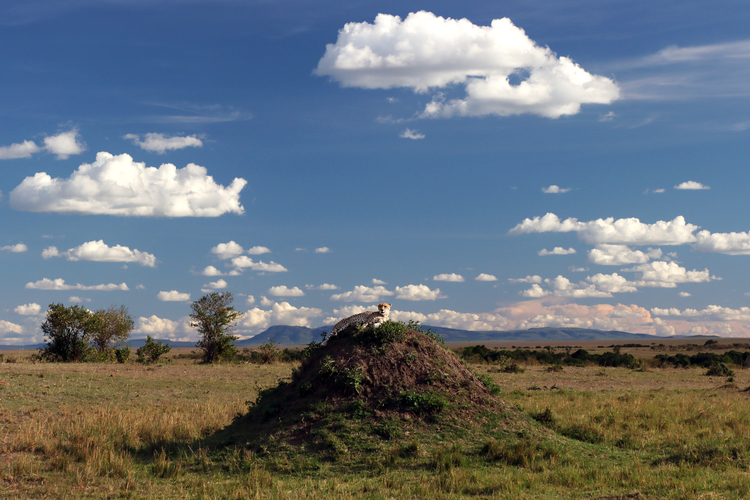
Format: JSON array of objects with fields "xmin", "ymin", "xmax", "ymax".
[{"xmin": 0, "ymin": 340, "xmax": 750, "ymax": 499}]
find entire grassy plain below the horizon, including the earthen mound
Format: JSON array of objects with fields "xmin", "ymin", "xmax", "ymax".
[{"xmin": 0, "ymin": 323, "xmax": 750, "ymax": 499}]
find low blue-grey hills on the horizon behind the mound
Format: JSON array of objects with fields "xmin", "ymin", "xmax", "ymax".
[{"xmin": 236, "ymin": 325, "xmax": 659, "ymax": 347}]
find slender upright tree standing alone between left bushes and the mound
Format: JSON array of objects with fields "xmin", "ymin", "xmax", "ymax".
[{"xmin": 190, "ymin": 292, "xmax": 242, "ymax": 363}]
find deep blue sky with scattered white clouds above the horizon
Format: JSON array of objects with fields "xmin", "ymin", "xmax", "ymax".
[{"xmin": 0, "ymin": 0, "xmax": 750, "ymax": 344}]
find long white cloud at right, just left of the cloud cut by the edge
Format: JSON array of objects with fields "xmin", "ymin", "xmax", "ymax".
[{"xmin": 509, "ymin": 213, "xmax": 699, "ymax": 245}]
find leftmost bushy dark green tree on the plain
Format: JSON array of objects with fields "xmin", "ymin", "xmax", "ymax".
[{"xmin": 39, "ymin": 304, "xmax": 99, "ymax": 361}]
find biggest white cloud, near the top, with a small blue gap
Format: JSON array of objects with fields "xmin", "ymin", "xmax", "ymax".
[{"xmin": 315, "ymin": 11, "xmax": 619, "ymax": 118}]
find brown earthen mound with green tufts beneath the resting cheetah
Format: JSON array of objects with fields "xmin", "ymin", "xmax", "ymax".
[{"xmin": 207, "ymin": 322, "xmax": 519, "ymax": 466}]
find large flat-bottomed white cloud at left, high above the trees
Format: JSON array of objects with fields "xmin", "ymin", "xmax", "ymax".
[{"xmin": 10, "ymin": 152, "xmax": 247, "ymax": 217}]
